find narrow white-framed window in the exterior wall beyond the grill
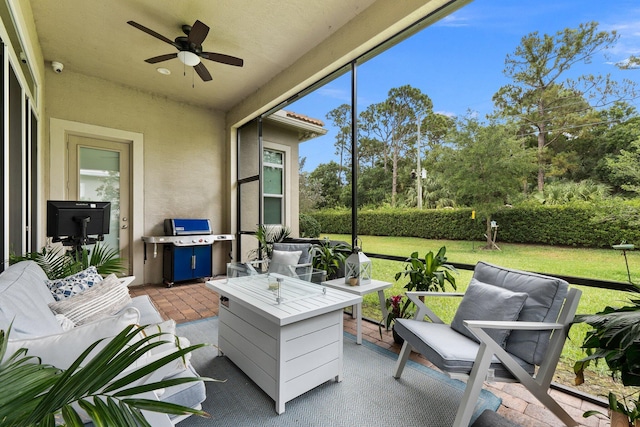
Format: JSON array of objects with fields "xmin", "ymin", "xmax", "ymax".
[{"xmin": 262, "ymin": 148, "xmax": 284, "ymax": 224}]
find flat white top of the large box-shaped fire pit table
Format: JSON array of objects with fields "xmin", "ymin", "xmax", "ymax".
[{"xmin": 206, "ymin": 273, "xmax": 362, "ymax": 326}]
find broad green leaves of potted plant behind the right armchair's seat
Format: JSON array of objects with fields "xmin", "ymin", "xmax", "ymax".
[{"xmin": 395, "ymin": 246, "xmax": 457, "ymax": 292}]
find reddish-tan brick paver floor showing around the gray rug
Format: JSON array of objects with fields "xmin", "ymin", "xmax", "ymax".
[{"xmin": 130, "ymin": 282, "xmax": 609, "ymax": 427}]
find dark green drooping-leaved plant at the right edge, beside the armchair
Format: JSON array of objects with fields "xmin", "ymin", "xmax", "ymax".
[{"xmin": 574, "ymin": 299, "xmax": 640, "ymax": 426}]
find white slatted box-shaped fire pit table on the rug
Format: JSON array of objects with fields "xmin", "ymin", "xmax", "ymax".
[{"xmin": 207, "ymin": 274, "xmax": 362, "ymax": 414}]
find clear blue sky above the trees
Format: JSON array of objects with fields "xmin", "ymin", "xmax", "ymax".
[{"xmin": 286, "ymin": 0, "xmax": 640, "ymax": 171}]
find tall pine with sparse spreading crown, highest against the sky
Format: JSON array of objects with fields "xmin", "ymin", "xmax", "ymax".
[{"xmin": 493, "ymin": 22, "xmax": 636, "ymax": 191}]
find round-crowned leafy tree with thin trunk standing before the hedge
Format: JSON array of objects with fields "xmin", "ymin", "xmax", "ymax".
[{"xmin": 436, "ymin": 116, "xmax": 535, "ymax": 249}]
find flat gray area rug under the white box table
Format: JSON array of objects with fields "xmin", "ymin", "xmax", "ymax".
[{"xmin": 178, "ymin": 317, "xmax": 501, "ymax": 427}]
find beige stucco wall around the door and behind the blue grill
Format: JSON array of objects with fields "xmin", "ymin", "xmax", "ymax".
[{"xmin": 43, "ymin": 70, "xmax": 231, "ymax": 283}]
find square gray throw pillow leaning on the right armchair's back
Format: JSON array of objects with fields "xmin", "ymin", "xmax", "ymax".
[{"xmin": 451, "ymin": 279, "xmax": 528, "ymax": 347}]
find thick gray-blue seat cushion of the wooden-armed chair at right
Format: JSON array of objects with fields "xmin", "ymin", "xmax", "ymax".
[{"xmin": 394, "ymin": 319, "xmax": 535, "ymax": 378}]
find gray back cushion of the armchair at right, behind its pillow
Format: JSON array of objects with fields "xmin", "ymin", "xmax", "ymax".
[{"xmin": 473, "ymin": 262, "xmax": 569, "ymax": 365}]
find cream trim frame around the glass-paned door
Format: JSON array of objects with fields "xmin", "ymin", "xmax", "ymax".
[{"xmin": 49, "ymin": 118, "xmax": 144, "ymax": 284}]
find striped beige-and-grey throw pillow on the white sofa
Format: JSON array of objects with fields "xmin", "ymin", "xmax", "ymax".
[{"xmin": 49, "ymin": 274, "xmax": 131, "ymax": 326}]
